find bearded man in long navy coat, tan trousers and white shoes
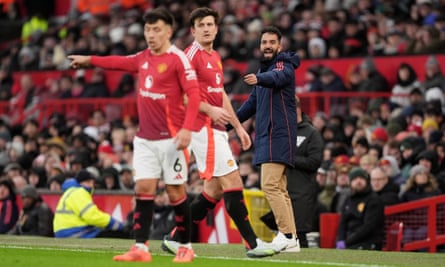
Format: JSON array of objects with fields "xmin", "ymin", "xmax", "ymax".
[{"xmin": 237, "ymin": 27, "xmax": 300, "ymax": 251}]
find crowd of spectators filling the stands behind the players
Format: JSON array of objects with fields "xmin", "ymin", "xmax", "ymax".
[{"xmin": 0, "ymin": 0, "xmax": 445, "ymax": 245}]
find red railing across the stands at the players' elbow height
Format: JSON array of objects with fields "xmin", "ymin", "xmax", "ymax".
[{"xmin": 0, "ymin": 92, "xmax": 390, "ymax": 127}]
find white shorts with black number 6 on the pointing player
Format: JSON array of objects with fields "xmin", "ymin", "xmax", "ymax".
[{"xmin": 133, "ymin": 136, "xmax": 189, "ymax": 185}]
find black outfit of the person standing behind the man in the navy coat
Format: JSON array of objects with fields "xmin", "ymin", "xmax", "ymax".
[{"xmin": 287, "ymin": 116, "xmax": 324, "ymax": 232}]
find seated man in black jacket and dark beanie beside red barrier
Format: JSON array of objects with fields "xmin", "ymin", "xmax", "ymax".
[{"xmin": 336, "ymin": 167, "xmax": 385, "ymax": 250}]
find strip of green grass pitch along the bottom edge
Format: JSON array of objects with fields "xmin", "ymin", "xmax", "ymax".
[{"xmin": 0, "ymin": 235, "xmax": 445, "ymax": 267}]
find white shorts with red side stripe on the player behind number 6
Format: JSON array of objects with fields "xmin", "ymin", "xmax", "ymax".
[{"xmin": 190, "ymin": 125, "xmax": 238, "ymax": 180}]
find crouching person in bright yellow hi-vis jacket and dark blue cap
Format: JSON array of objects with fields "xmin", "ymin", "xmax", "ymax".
[{"xmin": 54, "ymin": 179, "xmax": 123, "ymax": 238}]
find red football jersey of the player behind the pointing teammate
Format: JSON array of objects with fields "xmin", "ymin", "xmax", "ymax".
[{"xmin": 185, "ymin": 41, "xmax": 225, "ymax": 130}]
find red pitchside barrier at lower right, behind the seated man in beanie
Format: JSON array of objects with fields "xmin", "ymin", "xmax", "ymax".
[{"xmin": 320, "ymin": 195, "xmax": 445, "ymax": 252}]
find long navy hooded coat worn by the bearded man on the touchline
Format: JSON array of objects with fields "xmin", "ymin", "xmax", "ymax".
[{"xmin": 237, "ymin": 52, "xmax": 300, "ymax": 167}]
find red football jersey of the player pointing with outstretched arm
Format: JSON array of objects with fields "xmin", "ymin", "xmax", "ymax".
[{"xmin": 91, "ymin": 45, "xmax": 200, "ymax": 140}]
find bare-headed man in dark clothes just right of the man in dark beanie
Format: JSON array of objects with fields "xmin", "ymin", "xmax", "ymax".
[{"xmin": 370, "ymin": 167, "xmax": 400, "ymax": 206}]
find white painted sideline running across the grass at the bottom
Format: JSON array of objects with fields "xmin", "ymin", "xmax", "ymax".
[{"xmin": 0, "ymin": 245, "xmax": 394, "ymax": 267}]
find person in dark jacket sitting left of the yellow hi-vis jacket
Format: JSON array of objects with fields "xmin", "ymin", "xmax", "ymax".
[{"xmin": 14, "ymin": 185, "xmax": 54, "ymax": 236}]
